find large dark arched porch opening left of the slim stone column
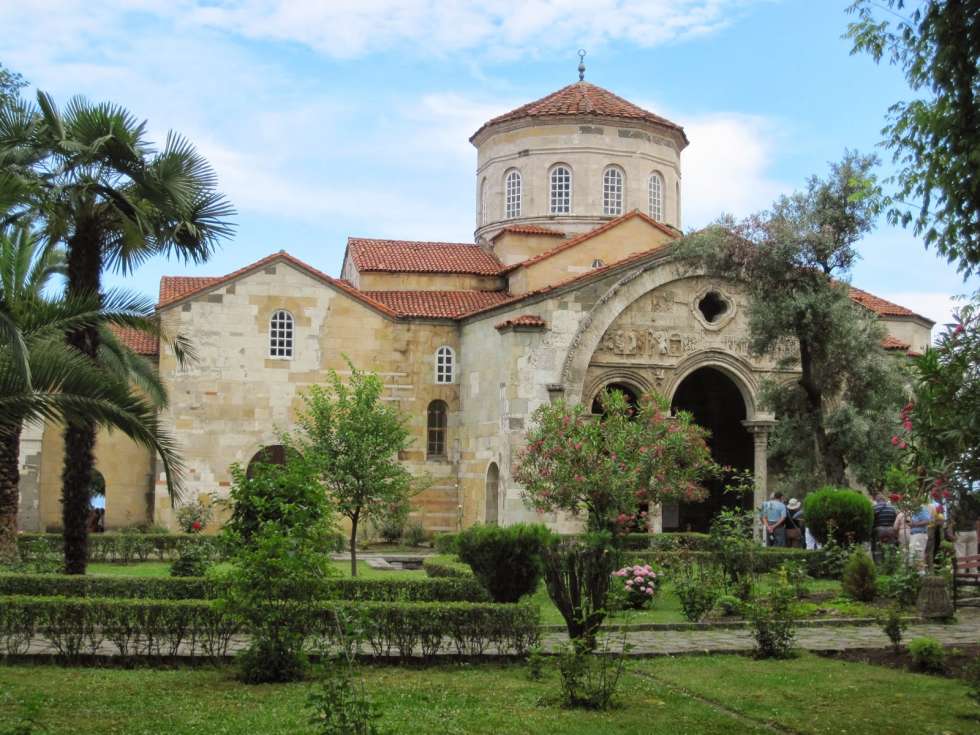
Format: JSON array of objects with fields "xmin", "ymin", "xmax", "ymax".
[{"xmin": 663, "ymin": 367, "xmax": 753, "ymax": 532}]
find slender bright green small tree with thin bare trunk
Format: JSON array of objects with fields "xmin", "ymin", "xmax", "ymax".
[{"xmin": 295, "ymin": 363, "xmax": 413, "ymax": 576}]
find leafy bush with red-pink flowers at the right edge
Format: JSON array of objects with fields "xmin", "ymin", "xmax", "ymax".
[{"xmin": 890, "ymin": 294, "xmax": 980, "ymax": 529}]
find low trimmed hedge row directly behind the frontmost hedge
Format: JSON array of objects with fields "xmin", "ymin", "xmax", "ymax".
[{"xmin": 0, "ymin": 574, "xmax": 488, "ymax": 602}]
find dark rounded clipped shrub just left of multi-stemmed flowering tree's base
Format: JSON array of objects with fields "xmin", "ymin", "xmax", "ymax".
[{"xmin": 457, "ymin": 523, "xmax": 553, "ymax": 602}]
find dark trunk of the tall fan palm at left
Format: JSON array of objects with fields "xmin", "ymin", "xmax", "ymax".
[{"xmin": 61, "ymin": 220, "xmax": 102, "ymax": 574}]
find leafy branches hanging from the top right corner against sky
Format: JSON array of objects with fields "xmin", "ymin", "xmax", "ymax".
[{"xmin": 847, "ymin": 0, "xmax": 980, "ymax": 277}]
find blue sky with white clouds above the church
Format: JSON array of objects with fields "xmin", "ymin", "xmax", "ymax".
[{"xmin": 0, "ymin": 0, "xmax": 980, "ymax": 330}]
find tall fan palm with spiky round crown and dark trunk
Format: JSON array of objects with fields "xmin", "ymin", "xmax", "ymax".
[{"xmin": 0, "ymin": 92, "xmax": 233, "ymax": 574}]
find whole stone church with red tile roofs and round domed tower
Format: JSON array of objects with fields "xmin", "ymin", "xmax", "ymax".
[{"xmin": 20, "ymin": 81, "xmax": 932, "ymax": 530}]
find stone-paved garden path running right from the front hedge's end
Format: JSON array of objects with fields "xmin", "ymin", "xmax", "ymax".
[{"xmin": 543, "ymin": 608, "xmax": 980, "ymax": 656}]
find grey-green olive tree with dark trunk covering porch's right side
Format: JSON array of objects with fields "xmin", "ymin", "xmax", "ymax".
[{"xmin": 682, "ymin": 153, "xmax": 902, "ymax": 489}]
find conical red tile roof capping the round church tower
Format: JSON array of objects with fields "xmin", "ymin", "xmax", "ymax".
[{"xmin": 470, "ymin": 82, "xmax": 687, "ymax": 143}]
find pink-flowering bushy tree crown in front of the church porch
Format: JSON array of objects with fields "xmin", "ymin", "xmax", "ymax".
[{"xmin": 515, "ymin": 392, "xmax": 718, "ymax": 534}]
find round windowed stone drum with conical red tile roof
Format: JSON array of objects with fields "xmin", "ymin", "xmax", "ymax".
[{"xmin": 470, "ymin": 80, "xmax": 688, "ymax": 245}]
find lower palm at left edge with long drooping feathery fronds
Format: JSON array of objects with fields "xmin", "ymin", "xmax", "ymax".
[{"xmin": 0, "ymin": 225, "xmax": 186, "ymax": 559}]
